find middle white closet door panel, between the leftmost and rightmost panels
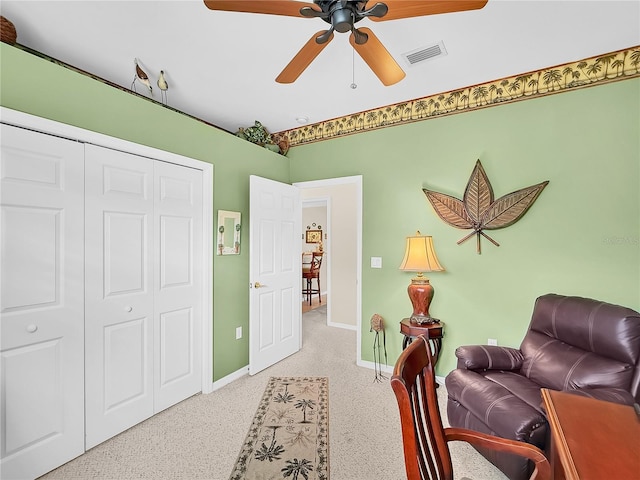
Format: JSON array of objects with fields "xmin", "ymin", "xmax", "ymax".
[{"xmin": 85, "ymin": 145, "xmax": 154, "ymax": 449}]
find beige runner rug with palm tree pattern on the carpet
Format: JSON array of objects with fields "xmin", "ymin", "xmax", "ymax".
[{"xmin": 230, "ymin": 377, "xmax": 329, "ymax": 480}]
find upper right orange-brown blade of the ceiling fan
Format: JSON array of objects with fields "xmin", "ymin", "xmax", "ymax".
[{"xmin": 365, "ymin": 0, "xmax": 488, "ymax": 22}]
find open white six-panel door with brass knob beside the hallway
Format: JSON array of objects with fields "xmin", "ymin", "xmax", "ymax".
[{"xmin": 249, "ymin": 175, "xmax": 302, "ymax": 375}]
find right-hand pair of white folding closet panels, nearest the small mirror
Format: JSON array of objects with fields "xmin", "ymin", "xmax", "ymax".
[{"xmin": 85, "ymin": 145, "xmax": 202, "ymax": 448}]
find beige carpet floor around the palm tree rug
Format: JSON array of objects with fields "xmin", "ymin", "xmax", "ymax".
[{"xmin": 44, "ymin": 307, "xmax": 506, "ymax": 480}]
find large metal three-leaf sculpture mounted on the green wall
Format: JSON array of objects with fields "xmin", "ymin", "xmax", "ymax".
[{"xmin": 422, "ymin": 160, "xmax": 549, "ymax": 253}]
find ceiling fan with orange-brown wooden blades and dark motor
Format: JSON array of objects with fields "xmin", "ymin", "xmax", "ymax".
[{"xmin": 204, "ymin": 0, "xmax": 488, "ymax": 86}]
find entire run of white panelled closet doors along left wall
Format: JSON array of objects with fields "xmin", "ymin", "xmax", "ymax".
[{"xmin": 0, "ymin": 125, "xmax": 203, "ymax": 478}]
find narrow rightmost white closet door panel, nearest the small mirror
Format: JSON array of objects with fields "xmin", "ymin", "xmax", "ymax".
[{"xmin": 153, "ymin": 162, "xmax": 204, "ymax": 412}]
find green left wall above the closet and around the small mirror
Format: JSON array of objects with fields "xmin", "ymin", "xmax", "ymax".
[{"xmin": 0, "ymin": 43, "xmax": 289, "ymax": 380}]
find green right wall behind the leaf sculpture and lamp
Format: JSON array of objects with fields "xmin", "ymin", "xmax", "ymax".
[{"xmin": 289, "ymin": 79, "xmax": 640, "ymax": 375}]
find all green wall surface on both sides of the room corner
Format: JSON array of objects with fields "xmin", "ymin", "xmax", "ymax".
[{"xmin": 0, "ymin": 44, "xmax": 640, "ymax": 380}]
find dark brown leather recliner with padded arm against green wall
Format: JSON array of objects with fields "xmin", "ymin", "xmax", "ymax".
[{"xmin": 445, "ymin": 294, "xmax": 640, "ymax": 480}]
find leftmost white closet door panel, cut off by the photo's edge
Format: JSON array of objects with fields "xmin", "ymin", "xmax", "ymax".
[{"xmin": 0, "ymin": 125, "xmax": 84, "ymax": 479}]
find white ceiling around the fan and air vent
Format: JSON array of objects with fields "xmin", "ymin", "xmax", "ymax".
[{"xmin": 0, "ymin": 0, "xmax": 640, "ymax": 132}]
